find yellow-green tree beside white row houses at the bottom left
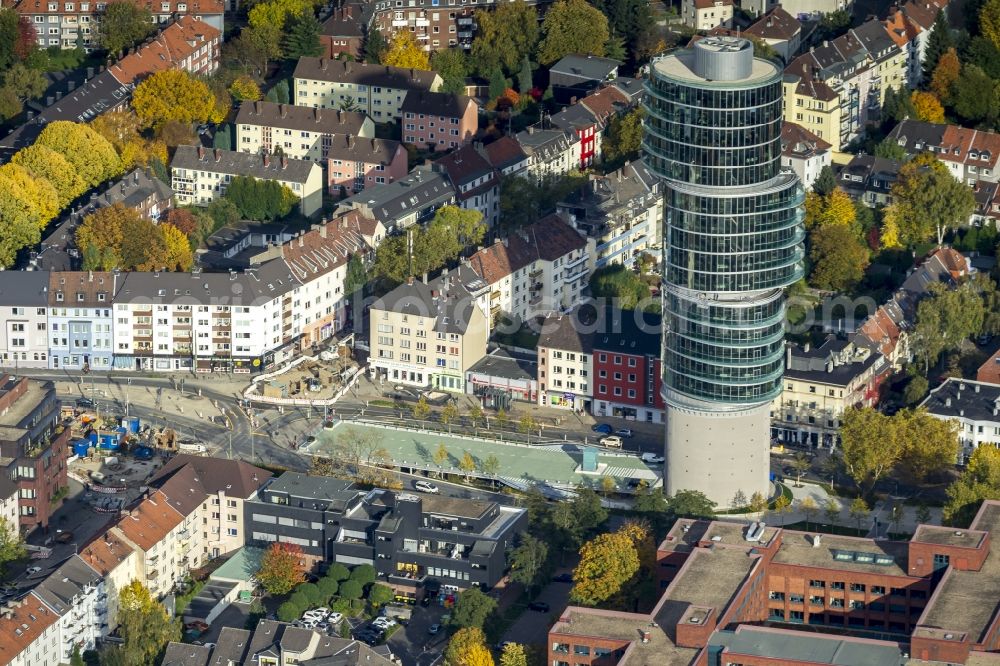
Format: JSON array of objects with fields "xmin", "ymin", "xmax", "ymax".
[{"xmin": 118, "ymin": 580, "xmax": 181, "ymax": 666}]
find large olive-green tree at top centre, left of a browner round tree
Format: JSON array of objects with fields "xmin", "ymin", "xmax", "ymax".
[{"xmin": 470, "ymin": 0, "xmax": 540, "ymax": 74}]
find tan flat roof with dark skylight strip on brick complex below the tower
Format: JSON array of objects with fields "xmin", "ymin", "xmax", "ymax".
[{"xmin": 773, "ymin": 530, "xmax": 908, "ymax": 576}]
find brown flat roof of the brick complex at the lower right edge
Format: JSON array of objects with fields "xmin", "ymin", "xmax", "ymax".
[{"xmin": 920, "ymin": 502, "xmax": 1000, "ymax": 642}]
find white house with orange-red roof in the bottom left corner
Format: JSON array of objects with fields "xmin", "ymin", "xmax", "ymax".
[{"xmin": 0, "ymin": 592, "xmax": 63, "ymax": 666}]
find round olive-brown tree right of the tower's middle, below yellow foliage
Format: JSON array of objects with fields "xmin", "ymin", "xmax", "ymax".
[{"xmin": 809, "ymin": 224, "xmax": 869, "ymax": 292}]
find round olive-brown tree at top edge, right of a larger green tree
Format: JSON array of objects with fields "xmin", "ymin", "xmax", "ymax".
[{"xmin": 538, "ymin": 0, "xmax": 611, "ymax": 65}]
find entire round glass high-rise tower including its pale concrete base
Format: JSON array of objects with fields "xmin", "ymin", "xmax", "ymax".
[{"xmin": 643, "ymin": 37, "xmax": 804, "ymax": 504}]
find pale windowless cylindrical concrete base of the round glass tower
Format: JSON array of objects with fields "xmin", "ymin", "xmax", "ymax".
[{"xmin": 663, "ymin": 404, "xmax": 771, "ymax": 509}]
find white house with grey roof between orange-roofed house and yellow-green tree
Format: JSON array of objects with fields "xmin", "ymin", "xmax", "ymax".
[{"xmin": 32, "ymin": 555, "xmax": 108, "ymax": 664}]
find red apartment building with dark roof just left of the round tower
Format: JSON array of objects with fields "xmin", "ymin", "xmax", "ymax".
[{"xmin": 593, "ymin": 307, "xmax": 665, "ymax": 423}]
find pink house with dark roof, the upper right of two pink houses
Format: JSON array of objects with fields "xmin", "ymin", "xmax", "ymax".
[{"xmin": 400, "ymin": 90, "xmax": 479, "ymax": 151}]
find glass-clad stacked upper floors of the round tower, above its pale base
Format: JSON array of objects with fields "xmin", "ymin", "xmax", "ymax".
[{"xmin": 643, "ymin": 40, "xmax": 804, "ymax": 407}]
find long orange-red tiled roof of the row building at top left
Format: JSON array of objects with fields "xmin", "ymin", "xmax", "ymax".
[{"xmin": 111, "ymin": 16, "xmax": 221, "ymax": 84}]
